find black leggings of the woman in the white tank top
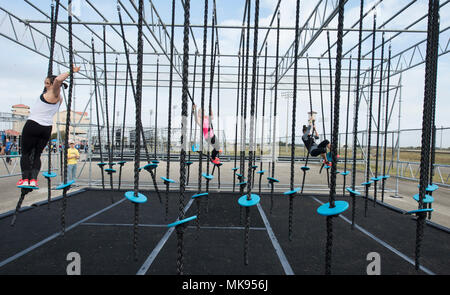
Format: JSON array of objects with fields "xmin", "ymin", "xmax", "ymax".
[{"xmin": 20, "ymin": 120, "xmax": 52, "ymax": 179}]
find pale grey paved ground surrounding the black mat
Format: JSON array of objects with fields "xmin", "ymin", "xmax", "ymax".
[{"xmin": 0, "ymin": 156, "xmax": 450, "ymax": 228}]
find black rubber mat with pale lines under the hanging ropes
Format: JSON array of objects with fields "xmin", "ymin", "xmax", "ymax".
[{"xmin": 0, "ymin": 190, "xmax": 450, "ymax": 275}]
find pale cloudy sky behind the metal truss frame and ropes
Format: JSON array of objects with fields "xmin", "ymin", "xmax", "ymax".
[{"xmin": 0, "ymin": 0, "xmax": 450, "ymax": 147}]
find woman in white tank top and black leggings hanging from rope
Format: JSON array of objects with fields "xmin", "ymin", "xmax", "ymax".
[{"xmin": 17, "ymin": 66, "xmax": 80, "ymax": 187}]
